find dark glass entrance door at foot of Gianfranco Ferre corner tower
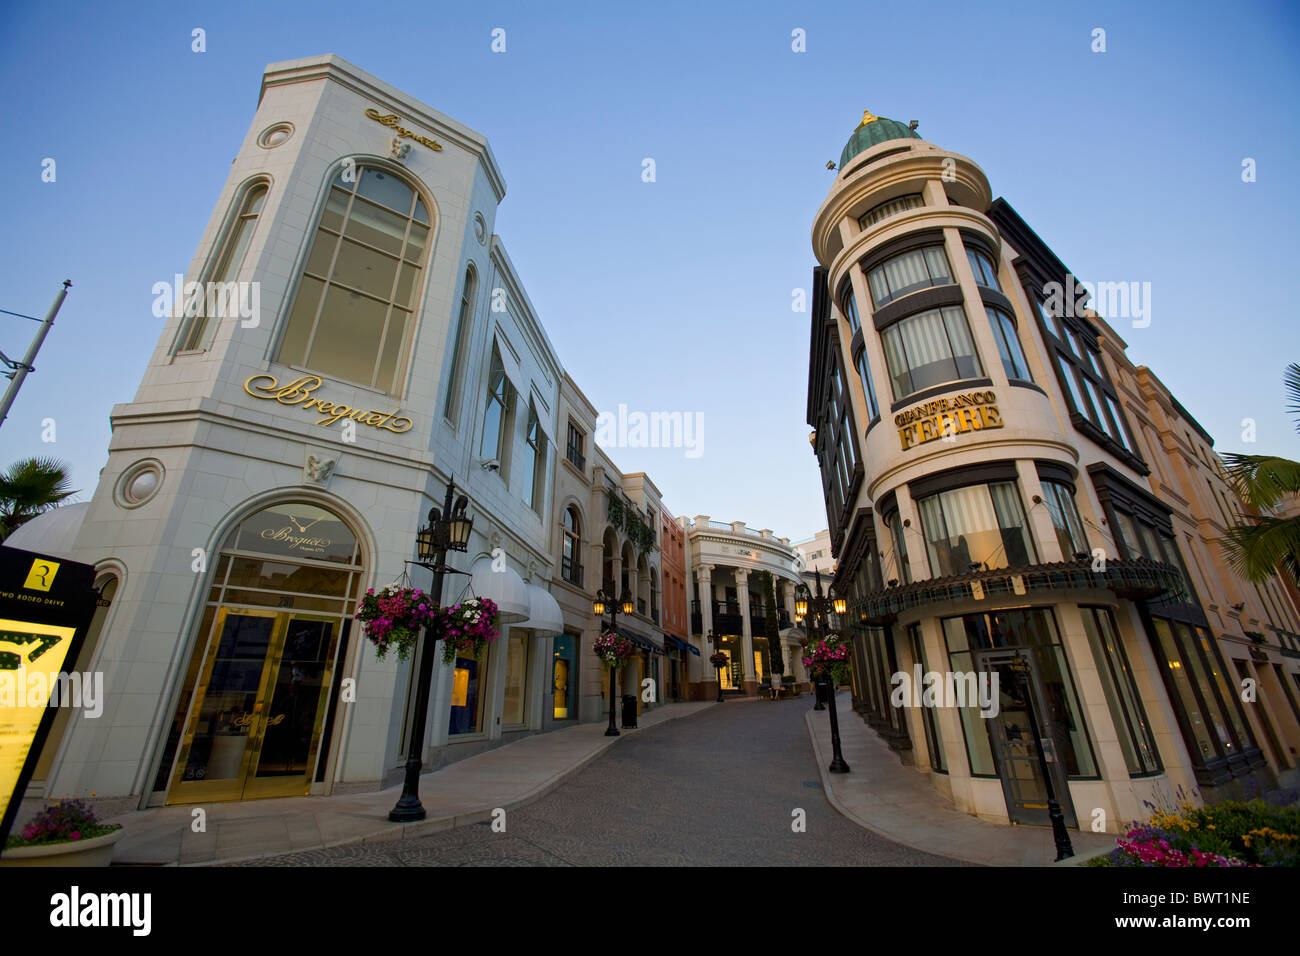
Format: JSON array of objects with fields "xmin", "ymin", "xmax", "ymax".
[{"xmin": 974, "ymin": 649, "xmax": 1078, "ymax": 827}]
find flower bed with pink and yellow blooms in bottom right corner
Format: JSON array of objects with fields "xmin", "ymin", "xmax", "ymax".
[{"xmin": 1087, "ymin": 800, "xmax": 1300, "ymax": 866}]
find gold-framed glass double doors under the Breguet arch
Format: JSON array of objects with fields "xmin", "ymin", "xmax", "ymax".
[{"xmin": 168, "ymin": 607, "xmax": 338, "ymax": 804}]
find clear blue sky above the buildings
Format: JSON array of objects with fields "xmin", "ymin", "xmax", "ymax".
[{"xmin": 0, "ymin": 0, "xmax": 1300, "ymax": 540}]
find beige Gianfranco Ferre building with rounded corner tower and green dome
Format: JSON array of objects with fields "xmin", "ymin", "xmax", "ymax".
[{"xmin": 807, "ymin": 113, "xmax": 1271, "ymax": 831}]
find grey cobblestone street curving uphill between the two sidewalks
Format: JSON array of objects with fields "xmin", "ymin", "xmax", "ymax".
[{"xmin": 231, "ymin": 697, "xmax": 962, "ymax": 866}]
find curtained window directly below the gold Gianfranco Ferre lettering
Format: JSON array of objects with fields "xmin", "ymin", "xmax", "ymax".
[{"xmin": 917, "ymin": 481, "xmax": 1036, "ymax": 578}]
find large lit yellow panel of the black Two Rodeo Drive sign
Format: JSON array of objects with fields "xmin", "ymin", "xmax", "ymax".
[{"xmin": 0, "ymin": 621, "xmax": 77, "ymax": 812}]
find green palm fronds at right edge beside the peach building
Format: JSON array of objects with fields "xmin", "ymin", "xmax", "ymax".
[{"xmin": 1222, "ymin": 362, "xmax": 1300, "ymax": 583}]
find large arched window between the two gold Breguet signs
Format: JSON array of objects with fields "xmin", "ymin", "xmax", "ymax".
[{"xmin": 278, "ymin": 166, "xmax": 430, "ymax": 393}]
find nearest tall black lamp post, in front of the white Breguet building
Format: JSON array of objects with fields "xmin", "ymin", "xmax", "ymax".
[{"xmin": 389, "ymin": 481, "xmax": 475, "ymax": 823}]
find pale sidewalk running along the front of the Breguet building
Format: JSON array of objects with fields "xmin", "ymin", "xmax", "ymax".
[{"xmin": 105, "ymin": 701, "xmax": 714, "ymax": 866}]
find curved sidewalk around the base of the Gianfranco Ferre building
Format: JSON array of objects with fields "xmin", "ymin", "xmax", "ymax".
[{"xmin": 805, "ymin": 692, "xmax": 1115, "ymax": 866}]
